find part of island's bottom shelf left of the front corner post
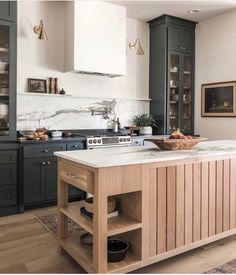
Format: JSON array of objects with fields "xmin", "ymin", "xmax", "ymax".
[{"xmin": 59, "ymin": 230, "xmax": 94, "ymax": 273}]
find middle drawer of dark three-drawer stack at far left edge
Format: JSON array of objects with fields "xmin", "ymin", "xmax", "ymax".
[{"xmin": 0, "ymin": 164, "xmax": 16, "ymax": 186}]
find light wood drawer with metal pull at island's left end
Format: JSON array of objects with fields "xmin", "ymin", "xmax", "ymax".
[{"xmin": 60, "ymin": 161, "xmax": 94, "ymax": 194}]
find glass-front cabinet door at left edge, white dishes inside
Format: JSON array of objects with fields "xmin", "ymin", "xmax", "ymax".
[{"xmin": 0, "ymin": 20, "xmax": 16, "ymax": 140}]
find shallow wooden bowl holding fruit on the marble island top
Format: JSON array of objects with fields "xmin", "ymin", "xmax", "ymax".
[{"xmin": 145, "ymin": 138, "xmax": 207, "ymax": 151}]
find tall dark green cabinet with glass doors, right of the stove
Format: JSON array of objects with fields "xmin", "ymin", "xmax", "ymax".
[{"xmin": 149, "ymin": 15, "xmax": 196, "ymax": 134}]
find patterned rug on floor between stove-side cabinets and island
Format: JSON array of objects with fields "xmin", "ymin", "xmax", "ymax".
[{"xmin": 35, "ymin": 214, "xmax": 81, "ymax": 238}]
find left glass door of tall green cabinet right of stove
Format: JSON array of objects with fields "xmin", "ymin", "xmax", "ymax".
[{"xmin": 167, "ymin": 53, "xmax": 180, "ymax": 134}]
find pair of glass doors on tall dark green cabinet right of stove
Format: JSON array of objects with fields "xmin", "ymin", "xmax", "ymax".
[{"xmin": 166, "ymin": 52, "xmax": 193, "ymax": 134}]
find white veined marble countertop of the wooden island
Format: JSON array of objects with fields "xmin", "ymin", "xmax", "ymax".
[{"xmin": 55, "ymin": 140, "xmax": 236, "ymax": 168}]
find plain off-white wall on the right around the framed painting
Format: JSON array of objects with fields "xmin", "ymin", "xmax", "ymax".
[{"xmin": 195, "ymin": 10, "xmax": 236, "ymax": 139}]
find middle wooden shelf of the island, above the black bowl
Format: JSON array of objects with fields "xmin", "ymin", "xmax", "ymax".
[{"xmin": 60, "ymin": 201, "xmax": 142, "ymax": 236}]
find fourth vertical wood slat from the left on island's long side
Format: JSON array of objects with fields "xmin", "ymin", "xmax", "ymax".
[{"xmin": 176, "ymin": 165, "xmax": 184, "ymax": 250}]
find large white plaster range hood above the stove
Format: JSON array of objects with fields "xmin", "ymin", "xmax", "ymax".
[{"xmin": 65, "ymin": 0, "xmax": 126, "ymax": 76}]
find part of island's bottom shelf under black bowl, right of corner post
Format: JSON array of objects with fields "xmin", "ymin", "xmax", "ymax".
[{"xmin": 107, "ymin": 252, "xmax": 142, "ymax": 273}]
